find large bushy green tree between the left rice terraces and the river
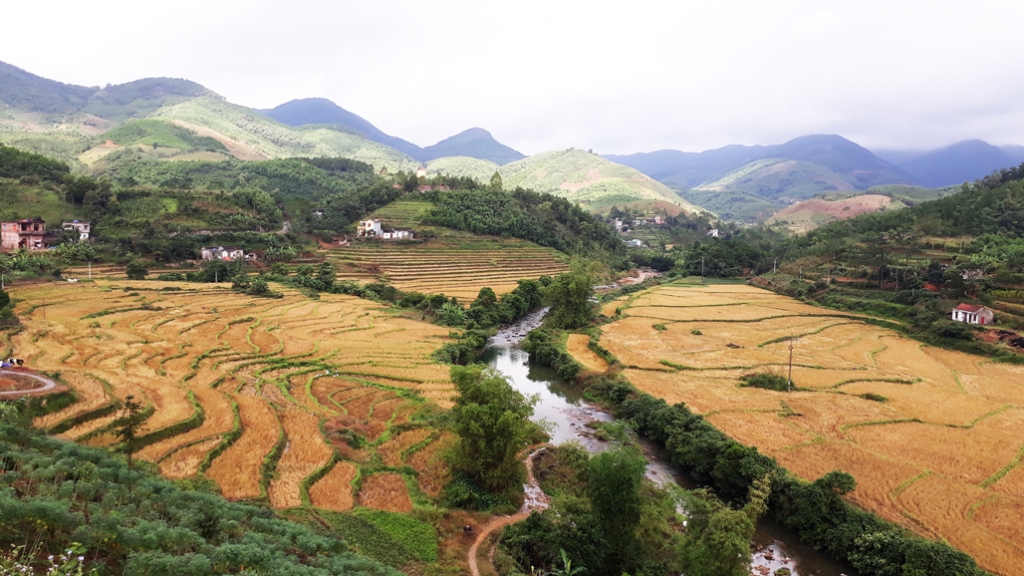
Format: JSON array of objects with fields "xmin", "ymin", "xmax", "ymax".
[{"xmin": 451, "ymin": 365, "xmax": 534, "ymax": 494}]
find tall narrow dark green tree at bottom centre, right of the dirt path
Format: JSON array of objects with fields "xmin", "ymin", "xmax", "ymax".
[{"xmin": 588, "ymin": 448, "xmax": 647, "ymax": 570}]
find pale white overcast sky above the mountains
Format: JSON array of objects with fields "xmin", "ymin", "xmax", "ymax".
[{"xmin": 0, "ymin": 0, "xmax": 1024, "ymax": 154}]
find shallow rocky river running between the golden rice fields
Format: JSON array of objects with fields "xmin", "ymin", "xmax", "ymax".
[{"xmin": 481, "ymin": 311, "xmax": 858, "ymax": 576}]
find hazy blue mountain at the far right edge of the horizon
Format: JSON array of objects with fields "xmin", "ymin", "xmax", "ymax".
[{"xmin": 882, "ymin": 139, "xmax": 1024, "ymax": 187}]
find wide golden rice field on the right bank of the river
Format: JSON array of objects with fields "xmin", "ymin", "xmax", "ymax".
[{"xmin": 589, "ymin": 285, "xmax": 1024, "ymax": 575}]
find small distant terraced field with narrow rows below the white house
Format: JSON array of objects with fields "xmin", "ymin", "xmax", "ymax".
[{"xmin": 325, "ymin": 237, "xmax": 568, "ymax": 300}]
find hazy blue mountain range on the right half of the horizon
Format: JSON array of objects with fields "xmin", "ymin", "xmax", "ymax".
[{"xmin": 606, "ymin": 134, "xmax": 1024, "ymax": 221}]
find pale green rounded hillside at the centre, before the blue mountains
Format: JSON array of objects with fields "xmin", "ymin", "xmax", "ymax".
[{"xmin": 499, "ymin": 149, "xmax": 699, "ymax": 212}]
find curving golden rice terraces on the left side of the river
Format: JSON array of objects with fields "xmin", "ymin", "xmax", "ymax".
[{"xmin": 4, "ymin": 281, "xmax": 454, "ymax": 510}]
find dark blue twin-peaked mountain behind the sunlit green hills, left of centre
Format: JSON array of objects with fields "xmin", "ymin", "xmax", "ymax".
[{"xmin": 260, "ymin": 98, "xmax": 524, "ymax": 164}]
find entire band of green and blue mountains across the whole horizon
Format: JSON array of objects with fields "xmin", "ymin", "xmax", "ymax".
[{"xmin": 0, "ymin": 56, "xmax": 1024, "ymax": 221}]
